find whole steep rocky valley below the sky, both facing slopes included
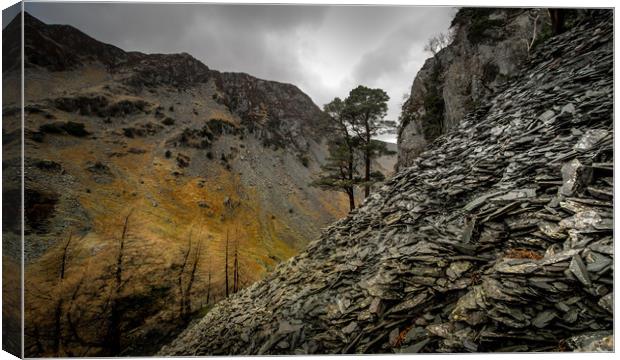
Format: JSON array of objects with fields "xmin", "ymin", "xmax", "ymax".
[{"xmin": 3, "ymin": 8, "xmax": 614, "ymax": 357}]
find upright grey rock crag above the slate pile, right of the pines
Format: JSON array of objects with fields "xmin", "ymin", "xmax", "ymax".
[{"xmin": 398, "ymin": 8, "xmax": 550, "ymax": 166}]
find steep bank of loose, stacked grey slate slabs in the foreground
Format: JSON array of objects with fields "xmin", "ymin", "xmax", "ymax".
[{"xmin": 160, "ymin": 11, "xmax": 613, "ymax": 355}]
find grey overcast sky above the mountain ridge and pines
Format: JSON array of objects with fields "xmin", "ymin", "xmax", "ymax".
[{"xmin": 20, "ymin": 3, "xmax": 456, "ymax": 141}]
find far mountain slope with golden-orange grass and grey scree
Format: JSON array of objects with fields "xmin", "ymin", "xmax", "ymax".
[{"xmin": 3, "ymin": 14, "xmax": 358, "ymax": 356}]
